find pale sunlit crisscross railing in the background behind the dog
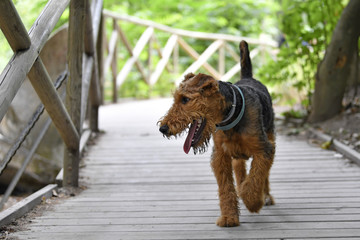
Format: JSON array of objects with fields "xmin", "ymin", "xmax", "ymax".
[{"xmin": 104, "ymin": 10, "xmax": 277, "ymax": 101}]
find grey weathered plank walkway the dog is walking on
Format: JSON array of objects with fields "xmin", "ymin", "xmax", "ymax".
[{"xmin": 10, "ymin": 100, "xmax": 360, "ymax": 240}]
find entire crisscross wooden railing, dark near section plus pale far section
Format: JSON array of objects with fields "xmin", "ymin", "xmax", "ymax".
[{"xmin": 0, "ymin": 0, "xmax": 276, "ymax": 210}]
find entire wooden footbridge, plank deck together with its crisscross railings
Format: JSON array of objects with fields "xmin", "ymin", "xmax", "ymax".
[{"xmin": 0, "ymin": 0, "xmax": 360, "ymax": 239}]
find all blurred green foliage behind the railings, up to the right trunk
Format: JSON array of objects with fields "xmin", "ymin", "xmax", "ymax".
[{"xmin": 0, "ymin": 0, "xmax": 348, "ymax": 113}]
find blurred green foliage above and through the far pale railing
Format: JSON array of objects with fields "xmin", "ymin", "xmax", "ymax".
[{"xmin": 104, "ymin": 0, "xmax": 279, "ymax": 98}]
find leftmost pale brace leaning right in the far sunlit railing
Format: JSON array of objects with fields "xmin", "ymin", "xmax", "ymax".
[{"xmin": 116, "ymin": 27, "xmax": 154, "ymax": 87}]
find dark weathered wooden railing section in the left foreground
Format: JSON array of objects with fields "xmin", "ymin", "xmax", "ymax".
[{"xmin": 0, "ymin": 0, "xmax": 103, "ymax": 207}]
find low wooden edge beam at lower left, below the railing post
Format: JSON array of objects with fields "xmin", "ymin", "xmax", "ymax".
[{"xmin": 0, "ymin": 184, "xmax": 57, "ymax": 226}]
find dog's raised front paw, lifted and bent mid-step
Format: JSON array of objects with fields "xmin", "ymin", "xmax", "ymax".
[{"xmin": 240, "ymin": 180, "xmax": 265, "ymax": 213}]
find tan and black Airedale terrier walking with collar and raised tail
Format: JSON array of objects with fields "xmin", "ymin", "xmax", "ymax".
[{"xmin": 159, "ymin": 41, "xmax": 275, "ymax": 227}]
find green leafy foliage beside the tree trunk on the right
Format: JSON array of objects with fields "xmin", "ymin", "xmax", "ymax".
[{"xmin": 259, "ymin": 0, "xmax": 348, "ymax": 109}]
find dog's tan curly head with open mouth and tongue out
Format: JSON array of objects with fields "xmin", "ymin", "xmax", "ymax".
[{"xmin": 159, "ymin": 73, "xmax": 225, "ymax": 153}]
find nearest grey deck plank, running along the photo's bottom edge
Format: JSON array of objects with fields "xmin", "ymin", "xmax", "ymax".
[{"xmin": 10, "ymin": 228, "xmax": 360, "ymax": 239}]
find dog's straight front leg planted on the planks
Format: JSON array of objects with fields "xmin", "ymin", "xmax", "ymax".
[{"xmin": 211, "ymin": 148, "xmax": 239, "ymax": 227}]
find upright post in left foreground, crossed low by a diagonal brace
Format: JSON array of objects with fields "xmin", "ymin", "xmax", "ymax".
[{"xmin": 63, "ymin": 0, "xmax": 86, "ymax": 187}]
